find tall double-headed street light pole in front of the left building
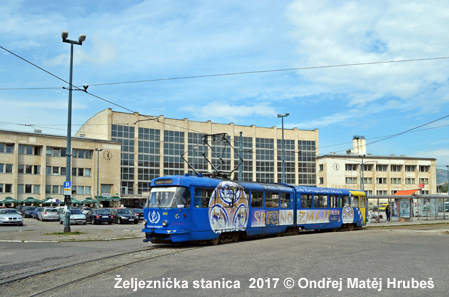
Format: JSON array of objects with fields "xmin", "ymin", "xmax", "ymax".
[{"xmin": 61, "ymin": 31, "xmax": 86, "ymax": 233}]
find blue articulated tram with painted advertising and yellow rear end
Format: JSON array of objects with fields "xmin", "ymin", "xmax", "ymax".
[{"xmin": 142, "ymin": 174, "xmax": 366, "ymax": 244}]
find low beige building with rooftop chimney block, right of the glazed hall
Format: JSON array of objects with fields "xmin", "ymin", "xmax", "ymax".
[{"xmin": 317, "ymin": 136, "xmax": 437, "ymax": 196}]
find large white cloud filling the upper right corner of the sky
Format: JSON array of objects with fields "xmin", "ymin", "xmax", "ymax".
[{"xmin": 287, "ymin": 0, "xmax": 449, "ymax": 108}]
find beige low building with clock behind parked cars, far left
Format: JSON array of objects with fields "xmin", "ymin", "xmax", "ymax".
[{"xmin": 0, "ymin": 130, "xmax": 121, "ymax": 206}]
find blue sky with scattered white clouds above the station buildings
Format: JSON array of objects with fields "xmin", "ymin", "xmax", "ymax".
[{"xmin": 0, "ymin": 0, "xmax": 449, "ymax": 168}]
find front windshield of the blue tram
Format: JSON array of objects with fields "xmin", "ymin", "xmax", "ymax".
[{"xmin": 145, "ymin": 187, "xmax": 190, "ymax": 208}]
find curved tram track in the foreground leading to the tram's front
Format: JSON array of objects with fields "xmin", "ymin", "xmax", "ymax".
[{"xmin": 0, "ymin": 246, "xmax": 201, "ymax": 296}]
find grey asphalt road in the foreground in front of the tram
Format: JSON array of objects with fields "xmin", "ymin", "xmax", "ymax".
[{"xmin": 0, "ymin": 225, "xmax": 449, "ymax": 297}]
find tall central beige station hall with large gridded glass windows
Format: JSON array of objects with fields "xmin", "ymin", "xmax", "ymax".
[{"xmin": 76, "ymin": 109, "xmax": 318, "ymax": 203}]
